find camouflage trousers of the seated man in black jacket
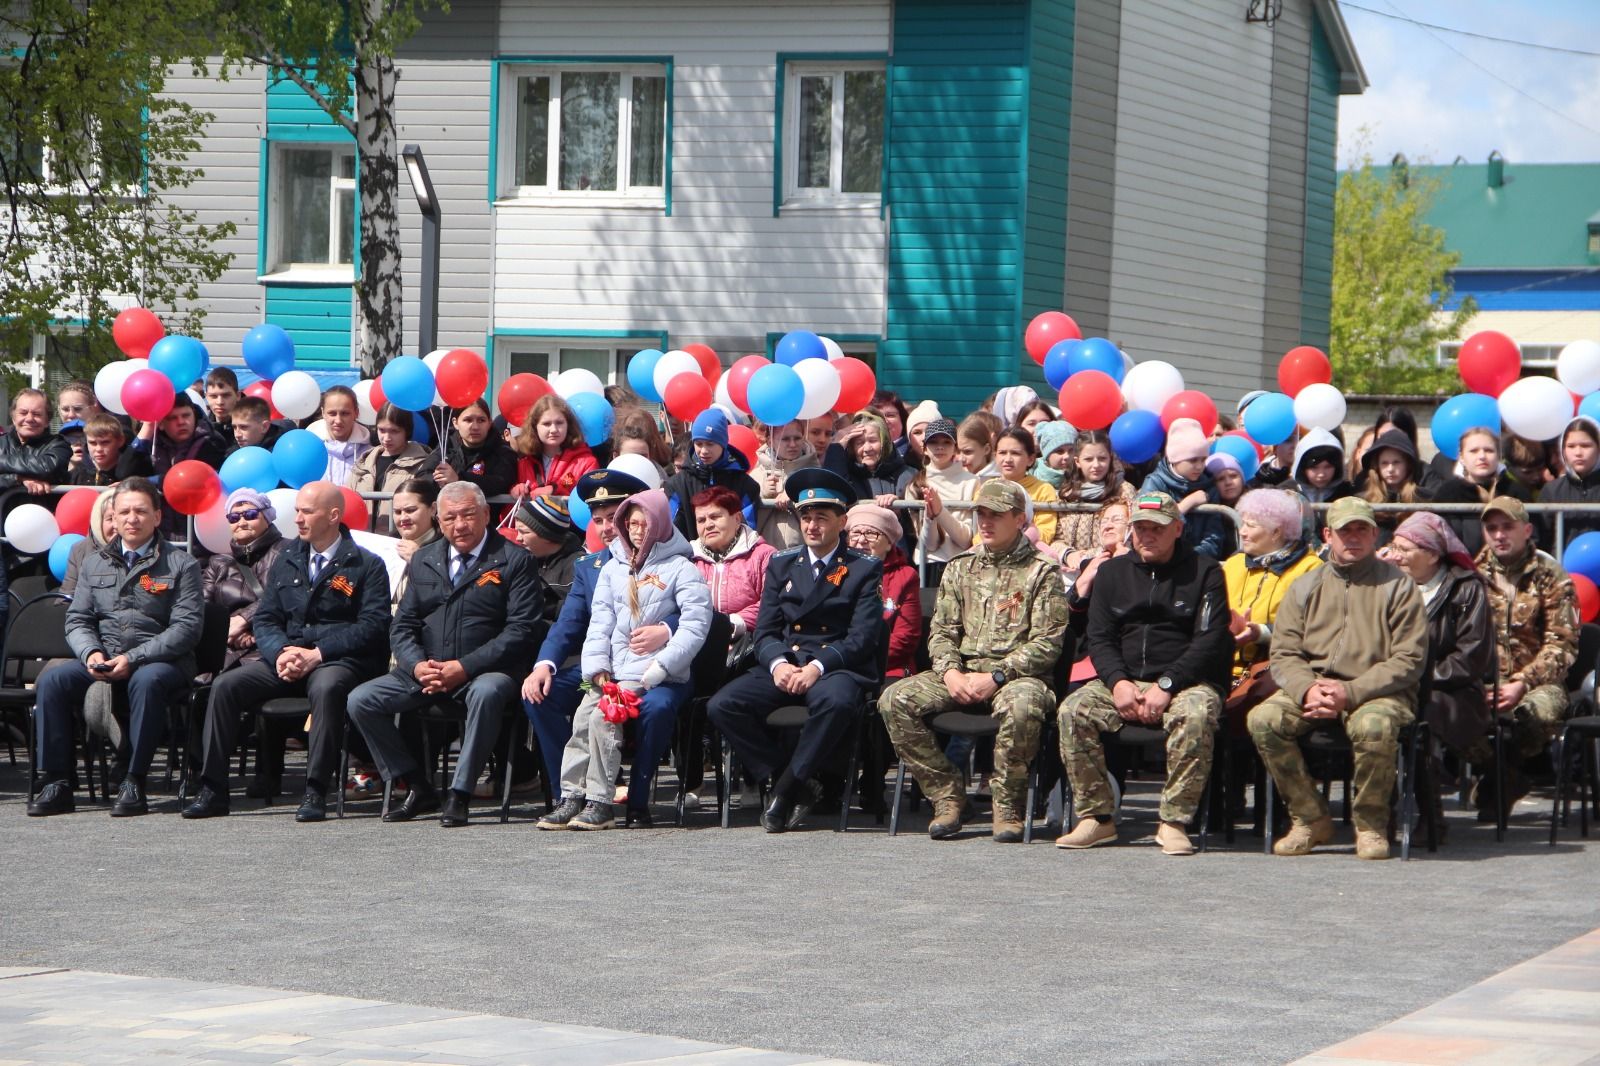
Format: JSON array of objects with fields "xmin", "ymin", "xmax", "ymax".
[{"xmin": 1059, "ymin": 680, "xmax": 1222, "ymax": 824}]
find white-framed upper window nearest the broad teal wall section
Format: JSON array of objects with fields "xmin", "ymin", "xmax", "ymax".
[{"xmin": 782, "ymin": 61, "xmax": 886, "ymax": 205}]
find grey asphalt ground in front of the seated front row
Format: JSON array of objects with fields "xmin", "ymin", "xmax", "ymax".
[{"xmin": 0, "ymin": 765, "xmax": 1600, "ymax": 1064}]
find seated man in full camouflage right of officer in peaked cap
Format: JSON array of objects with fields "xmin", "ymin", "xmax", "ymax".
[{"xmin": 878, "ymin": 479, "xmax": 1067, "ymax": 844}]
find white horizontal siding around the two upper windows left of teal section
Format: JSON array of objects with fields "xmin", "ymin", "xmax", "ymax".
[{"xmin": 492, "ymin": 0, "xmax": 890, "ymax": 359}]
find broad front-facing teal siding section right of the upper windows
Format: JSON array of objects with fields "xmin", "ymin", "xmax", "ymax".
[{"xmin": 878, "ymin": 0, "xmax": 1029, "ymax": 411}]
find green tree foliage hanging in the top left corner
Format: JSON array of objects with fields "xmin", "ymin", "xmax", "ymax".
[{"xmin": 0, "ymin": 0, "xmax": 235, "ymax": 384}]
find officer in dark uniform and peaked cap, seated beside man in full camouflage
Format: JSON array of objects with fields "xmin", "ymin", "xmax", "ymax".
[{"xmin": 707, "ymin": 467, "xmax": 883, "ymax": 832}]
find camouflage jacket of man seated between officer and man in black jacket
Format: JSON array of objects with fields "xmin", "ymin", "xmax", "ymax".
[{"xmin": 928, "ymin": 536, "xmax": 1067, "ymax": 680}]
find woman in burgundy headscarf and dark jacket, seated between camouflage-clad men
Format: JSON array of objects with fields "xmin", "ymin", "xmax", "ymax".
[{"xmin": 1384, "ymin": 511, "xmax": 1494, "ymax": 837}]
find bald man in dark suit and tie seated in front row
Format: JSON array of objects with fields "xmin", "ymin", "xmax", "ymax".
[{"xmin": 184, "ymin": 482, "xmax": 389, "ymax": 821}]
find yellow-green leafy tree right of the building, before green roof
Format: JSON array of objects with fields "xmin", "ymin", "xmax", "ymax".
[{"xmin": 1328, "ymin": 155, "xmax": 1477, "ymax": 395}]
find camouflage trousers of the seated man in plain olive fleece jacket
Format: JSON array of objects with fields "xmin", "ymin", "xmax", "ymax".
[{"xmin": 1248, "ymin": 691, "xmax": 1416, "ymax": 832}]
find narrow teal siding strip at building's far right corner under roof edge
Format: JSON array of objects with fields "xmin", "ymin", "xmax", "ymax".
[{"xmin": 1301, "ymin": 19, "xmax": 1339, "ymax": 347}]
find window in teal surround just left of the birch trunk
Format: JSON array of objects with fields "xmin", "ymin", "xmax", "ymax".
[{"xmin": 267, "ymin": 141, "xmax": 357, "ymax": 274}]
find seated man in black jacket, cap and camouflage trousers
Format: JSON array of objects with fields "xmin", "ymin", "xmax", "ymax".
[{"xmin": 1056, "ymin": 493, "xmax": 1234, "ymax": 855}]
